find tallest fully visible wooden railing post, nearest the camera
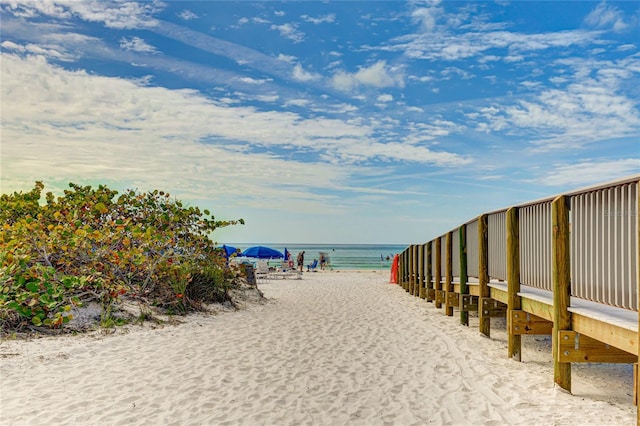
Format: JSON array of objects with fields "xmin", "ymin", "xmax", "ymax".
[{"xmin": 551, "ymin": 195, "xmax": 571, "ymax": 392}]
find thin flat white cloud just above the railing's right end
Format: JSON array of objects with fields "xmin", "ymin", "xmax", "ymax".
[{"xmin": 538, "ymin": 158, "xmax": 640, "ymax": 186}]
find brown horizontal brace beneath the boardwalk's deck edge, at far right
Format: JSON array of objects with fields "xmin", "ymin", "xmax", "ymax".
[{"xmin": 558, "ymin": 330, "xmax": 638, "ymax": 364}]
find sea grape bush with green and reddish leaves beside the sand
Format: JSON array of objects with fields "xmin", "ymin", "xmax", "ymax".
[{"xmin": 0, "ymin": 182, "xmax": 244, "ymax": 331}]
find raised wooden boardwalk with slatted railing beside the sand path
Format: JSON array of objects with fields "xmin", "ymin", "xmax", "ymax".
[{"xmin": 398, "ymin": 175, "xmax": 640, "ymax": 425}]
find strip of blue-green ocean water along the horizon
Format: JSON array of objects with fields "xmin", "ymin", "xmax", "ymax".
[{"xmin": 229, "ymin": 243, "xmax": 407, "ymax": 270}]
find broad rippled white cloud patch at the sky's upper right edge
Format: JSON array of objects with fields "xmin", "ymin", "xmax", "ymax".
[{"xmin": 470, "ymin": 57, "xmax": 640, "ymax": 150}]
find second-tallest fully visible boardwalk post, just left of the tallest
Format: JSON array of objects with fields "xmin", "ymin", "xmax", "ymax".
[{"xmin": 506, "ymin": 207, "xmax": 522, "ymax": 361}]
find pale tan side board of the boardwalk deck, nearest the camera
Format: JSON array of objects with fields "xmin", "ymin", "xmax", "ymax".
[{"xmin": 571, "ymin": 313, "xmax": 638, "ymax": 355}]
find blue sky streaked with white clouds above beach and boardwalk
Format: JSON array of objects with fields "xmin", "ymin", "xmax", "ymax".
[{"xmin": 0, "ymin": 0, "xmax": 640, "ymax": 244}]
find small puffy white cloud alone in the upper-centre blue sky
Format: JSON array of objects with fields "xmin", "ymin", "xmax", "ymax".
[{"xmin": 332, "ymin": 61, "xmax": 404, "ymax": 91}]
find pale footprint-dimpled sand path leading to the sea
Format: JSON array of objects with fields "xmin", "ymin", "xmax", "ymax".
[{"xmin": 0, "ymin": 271, "xmax": 636, "ymax": 425}]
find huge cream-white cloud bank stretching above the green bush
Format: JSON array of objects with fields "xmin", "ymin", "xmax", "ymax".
[{"xmin": 0, "ymin": 53, "xmax": 466, "ymax": 202}]
